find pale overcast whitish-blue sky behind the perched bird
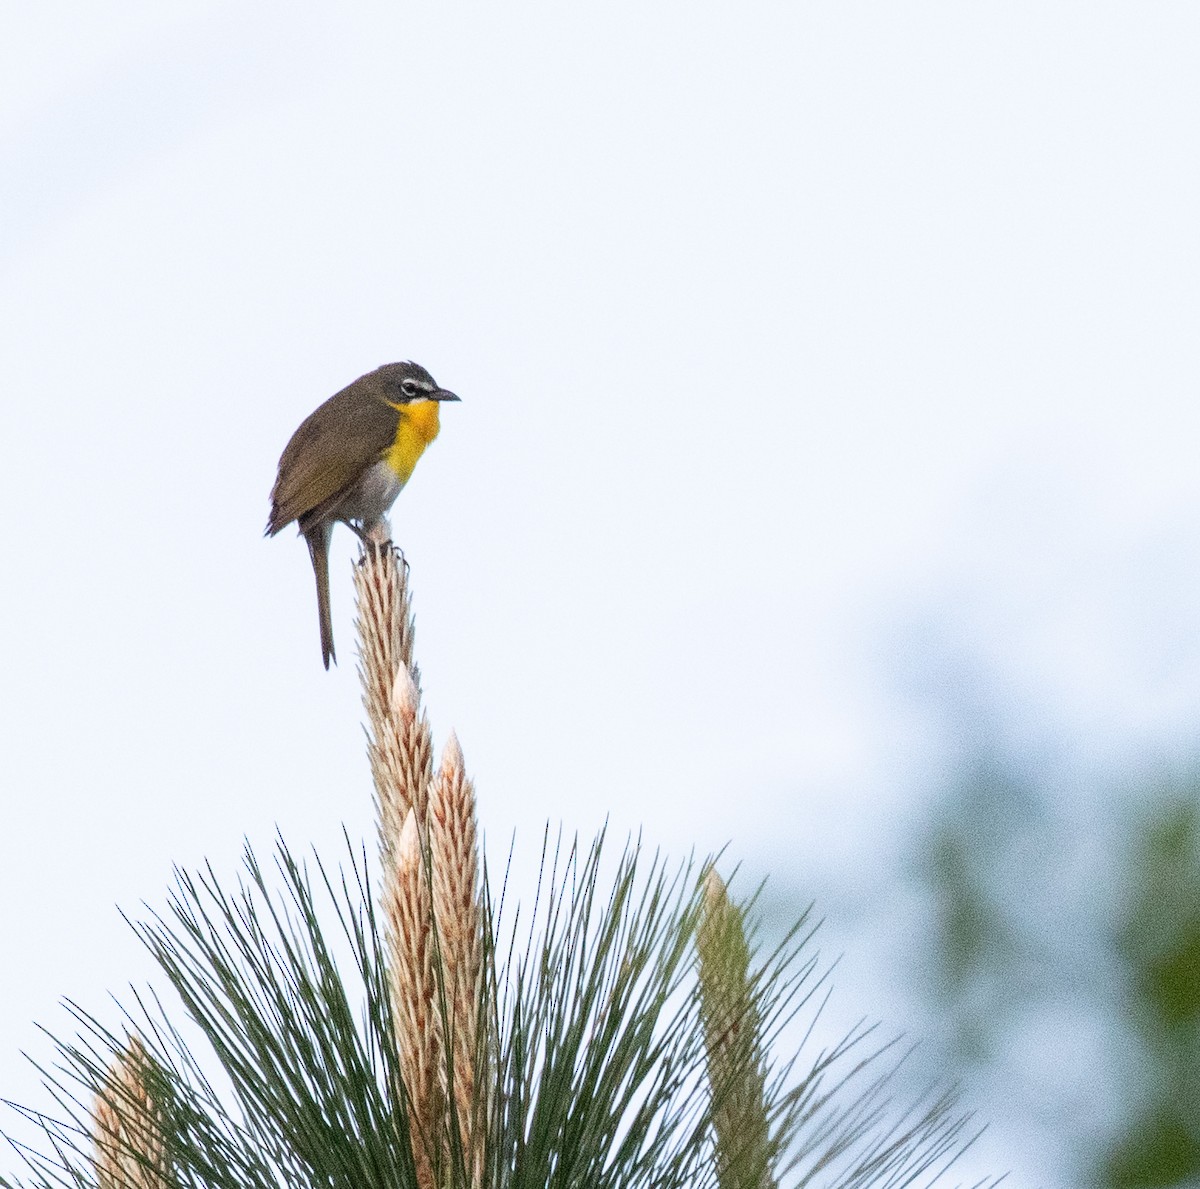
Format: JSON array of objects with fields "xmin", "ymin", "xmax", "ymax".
[{"xmin": 0, "ymin": 0, "xmax": 1200, "ymax": 1184}]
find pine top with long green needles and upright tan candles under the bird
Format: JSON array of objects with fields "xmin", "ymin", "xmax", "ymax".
[{"xmin": 0, "ymin": 550, "xmax": 998, "ymax": 1189}]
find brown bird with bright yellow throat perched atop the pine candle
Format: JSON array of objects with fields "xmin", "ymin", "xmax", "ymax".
[{"xmin": 264, "ymin": 361, "xmax": 460, "ymax": 669}]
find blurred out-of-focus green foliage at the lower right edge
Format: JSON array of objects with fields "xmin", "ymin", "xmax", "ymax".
[{"xmin": 913, "ymin": 756, "xmax": 1200, "ymax": 1189}]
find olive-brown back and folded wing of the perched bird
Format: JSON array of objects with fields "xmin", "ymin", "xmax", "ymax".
[{"xmin": 266, "ymin": 376, "xmax": 400, "ymax": 536}]
